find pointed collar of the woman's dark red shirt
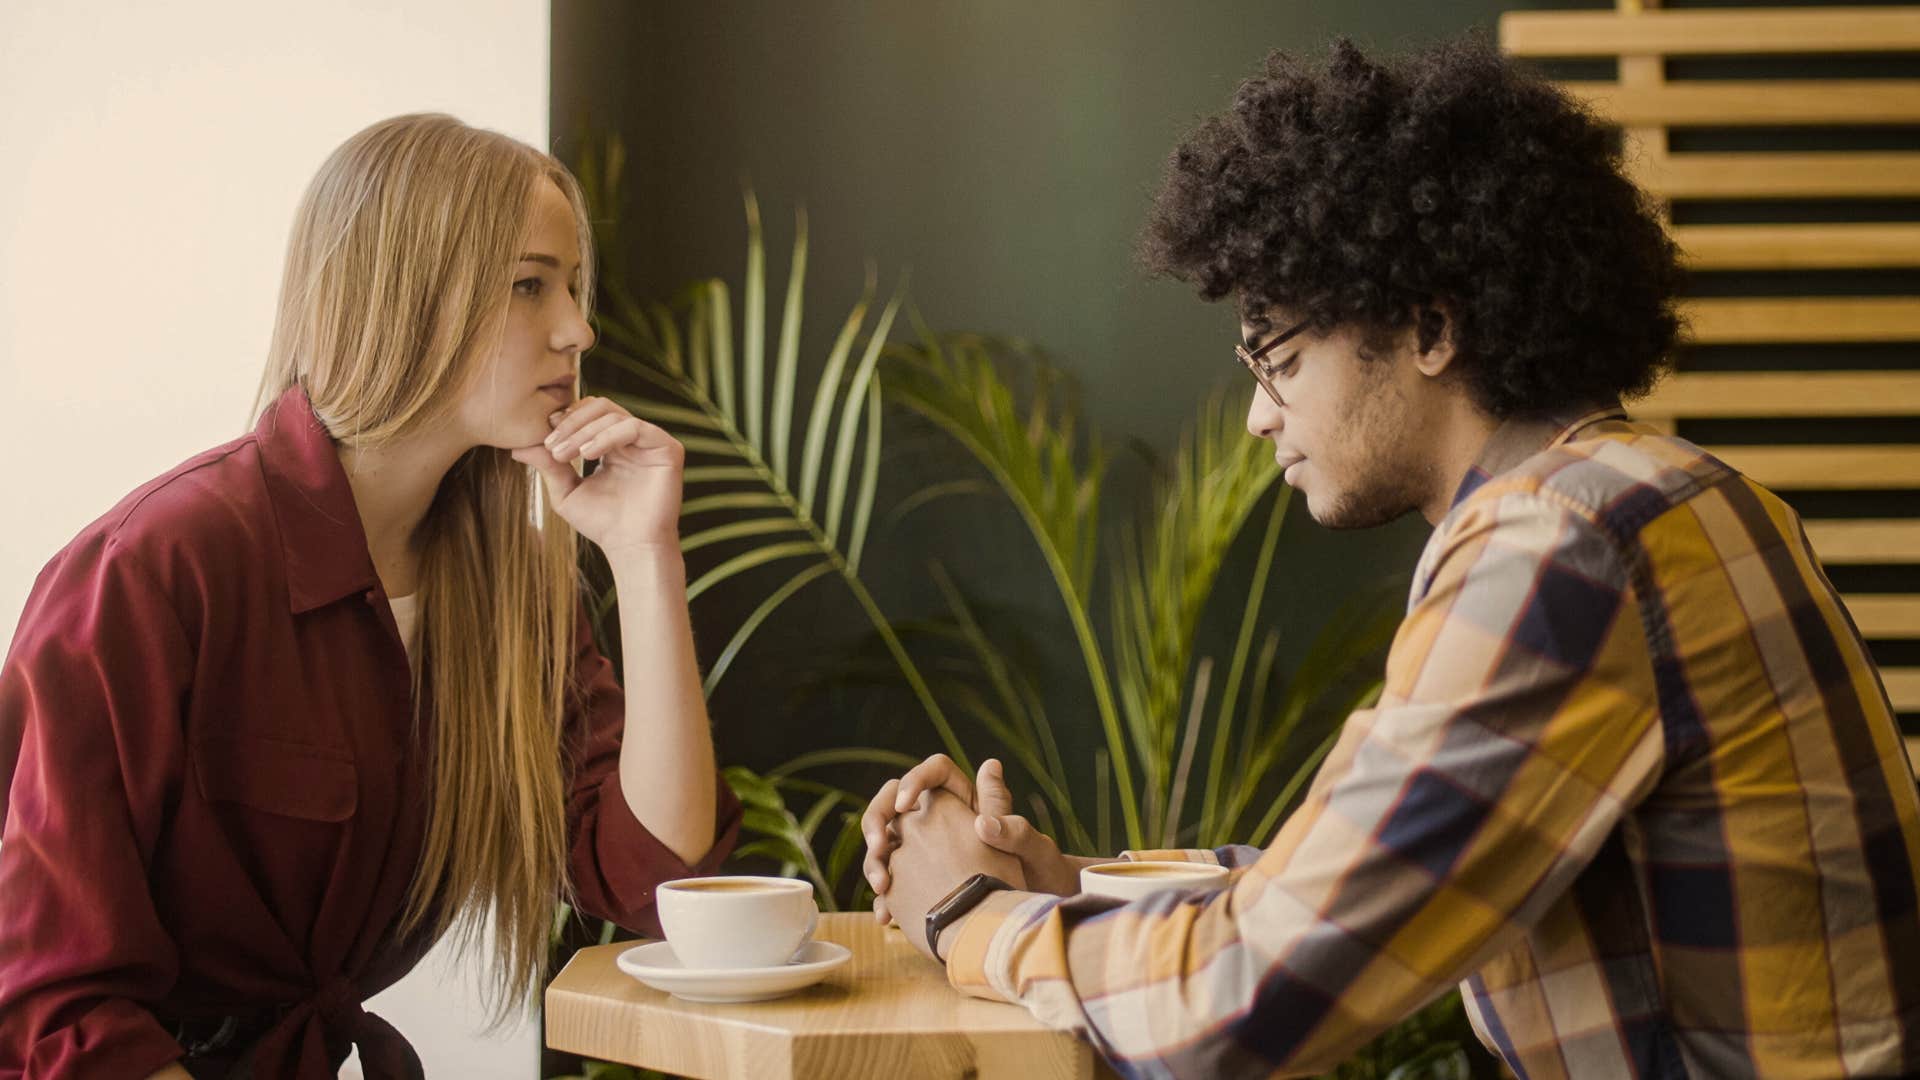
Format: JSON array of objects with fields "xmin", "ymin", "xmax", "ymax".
[{"xmin": 253, "ymin": 384, "xmax": 380, "ymax": 615}]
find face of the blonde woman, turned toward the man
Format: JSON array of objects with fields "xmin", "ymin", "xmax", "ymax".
[{"xmin": 459, "ymin": 179, "xmax": 593, "ymax": 450}]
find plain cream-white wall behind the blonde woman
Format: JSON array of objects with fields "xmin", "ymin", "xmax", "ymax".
[{"xmin": 0, "ymin": 0, "xmax": 549, "ymax": 1078}]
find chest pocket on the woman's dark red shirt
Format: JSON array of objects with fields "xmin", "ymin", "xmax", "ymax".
[{"xmin": 192, "ymin": 734, "xmax": 359, "ymax": 822}]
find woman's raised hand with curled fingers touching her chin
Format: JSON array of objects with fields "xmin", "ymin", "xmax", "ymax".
[{"xmin": 513, "ymin": 398, "xmax": 685, "ymax": 561}]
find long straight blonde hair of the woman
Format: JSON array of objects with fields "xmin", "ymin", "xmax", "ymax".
[{"xmin": 255, "ymin": 113, "xmax": 593, "ymax": 1020}]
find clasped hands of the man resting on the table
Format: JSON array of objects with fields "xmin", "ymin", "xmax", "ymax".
[{"xmin": 860, "ymin": 753, "xmax": 1094, "ymax": 959}]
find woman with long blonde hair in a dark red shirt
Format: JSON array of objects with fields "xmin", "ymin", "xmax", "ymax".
[{"xmin": 0, "ymin": 115, "xmax": 739, "ymax": 1078}]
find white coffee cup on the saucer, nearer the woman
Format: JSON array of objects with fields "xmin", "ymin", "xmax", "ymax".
[{"xmin": 653, "ymin": 876, "xmax": 820, "ymax": 969}]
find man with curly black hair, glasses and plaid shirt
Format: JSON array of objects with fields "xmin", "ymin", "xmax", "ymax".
[{"xmin": 864, "ymin": 40, "xmax": 1920, "ymax": 1078}]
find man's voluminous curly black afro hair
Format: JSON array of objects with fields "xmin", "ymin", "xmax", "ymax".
[{"xmin": 1140, "ymin": 37, "xmax": 1682, "ymax": 417}]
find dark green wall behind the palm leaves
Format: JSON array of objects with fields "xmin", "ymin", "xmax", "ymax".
[{"xmin": 553, "ymin": 0, "xmax": 1607, "ymax": 780}]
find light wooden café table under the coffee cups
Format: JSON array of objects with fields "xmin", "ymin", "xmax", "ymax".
[{"xmin": 547, "ymin": 913, "xmax": 1110, "ymax": 1080}]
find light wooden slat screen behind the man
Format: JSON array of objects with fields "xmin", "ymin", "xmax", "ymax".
[{"xmin": 1500, "ymin": 0, "xmax": 1920, "ymax": 765}]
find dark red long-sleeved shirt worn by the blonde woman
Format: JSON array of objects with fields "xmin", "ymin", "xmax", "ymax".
[{"xmin": 0, "ymin": 388, "xmax": 739, "ymax": 1078}]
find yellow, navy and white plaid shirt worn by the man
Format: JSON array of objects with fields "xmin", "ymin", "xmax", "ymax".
[{"xmin": 948, "ymin": 411, "xmax": 1920, "ymax": 1080}]
